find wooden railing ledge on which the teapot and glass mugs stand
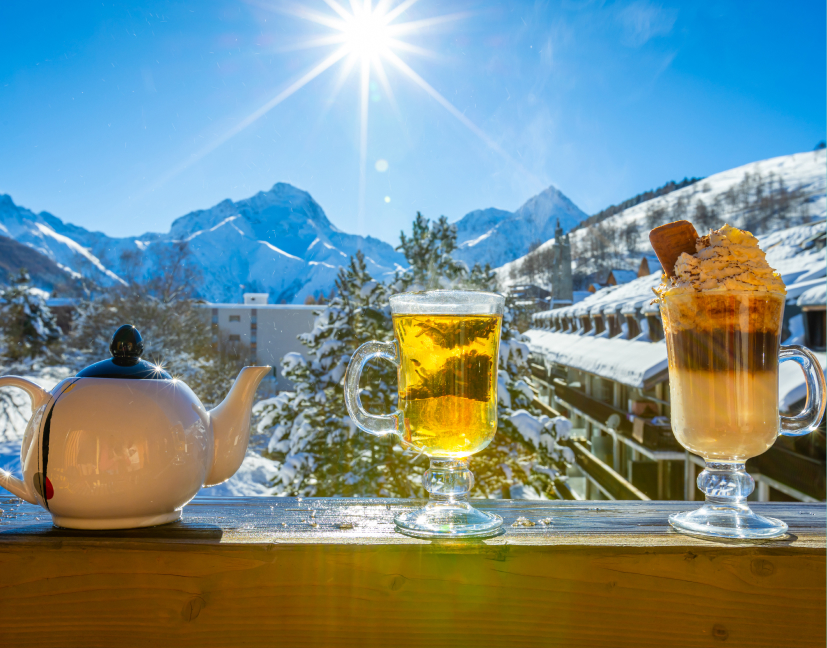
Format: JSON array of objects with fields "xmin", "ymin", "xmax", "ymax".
[{"xmin": 0, "ymin": 498, "xmax": 827, "ymax": 648}]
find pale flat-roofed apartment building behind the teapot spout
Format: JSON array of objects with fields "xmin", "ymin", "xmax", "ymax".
[{"xmin": 203, "ymin": 293, "xmax": 322, "ymax": 393}]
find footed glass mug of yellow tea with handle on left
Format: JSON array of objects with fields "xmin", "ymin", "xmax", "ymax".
[{"xmin": 345, "ymin": 290, "xmax": 505, "ymax": 538}]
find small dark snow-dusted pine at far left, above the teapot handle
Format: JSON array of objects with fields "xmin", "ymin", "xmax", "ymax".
[{"xmin": 0, "ymin": 270, "xmax": 61, "ymax": 361}]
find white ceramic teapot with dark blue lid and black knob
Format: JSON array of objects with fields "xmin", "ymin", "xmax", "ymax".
[{"xmin": 0, "ymin": 326, "xmax": 271, "ymax": 529}]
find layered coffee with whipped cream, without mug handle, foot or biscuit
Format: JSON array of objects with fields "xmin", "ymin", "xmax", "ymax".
[{"xmin": 656, "ymin": 226, "xmax": 785, "ymax": 463}]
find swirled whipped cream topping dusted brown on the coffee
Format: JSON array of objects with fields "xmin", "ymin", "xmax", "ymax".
[{"xmin": 656, "ymin": 225, "xmax": 786, "ymax": 295}]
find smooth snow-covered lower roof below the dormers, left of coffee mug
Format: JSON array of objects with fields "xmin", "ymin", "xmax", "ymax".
[{"xmin": 526, "ymin": 330, "xmax": 668, "ymax": 388}]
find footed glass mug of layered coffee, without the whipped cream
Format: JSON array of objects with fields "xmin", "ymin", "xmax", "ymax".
[{"xmin": 661, "ymin": 290, "xmax": 824, "ymax": 538}]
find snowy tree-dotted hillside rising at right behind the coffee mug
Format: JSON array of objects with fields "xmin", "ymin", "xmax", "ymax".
[{"xmin": 497, "ymin": 149, "xmax": 827, "ymax": 287}]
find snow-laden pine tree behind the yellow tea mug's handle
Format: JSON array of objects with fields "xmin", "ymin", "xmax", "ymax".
[{"xmin": 259, "ymin": 252, "xmax": 424, "ymax": 497}]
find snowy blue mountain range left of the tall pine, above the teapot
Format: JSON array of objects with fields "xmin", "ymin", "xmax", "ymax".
[{"xmin": 0, "ymin": 183, "xmax": 404, "ymax": 303}]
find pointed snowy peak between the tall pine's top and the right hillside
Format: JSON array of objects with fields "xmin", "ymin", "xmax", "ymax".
[{"xmin": 454, "ymin": 186, "xmax": 588, "ymax": 268}]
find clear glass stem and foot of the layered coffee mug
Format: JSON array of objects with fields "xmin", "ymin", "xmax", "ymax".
[{"xmin": 669, "ymin": 461, "xmax": 787, "ymax": 540}]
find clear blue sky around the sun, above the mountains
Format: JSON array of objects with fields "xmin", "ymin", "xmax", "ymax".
[{"xmin": 0, "ymin": 0, "xmax": 827, "ymax": 243}]
